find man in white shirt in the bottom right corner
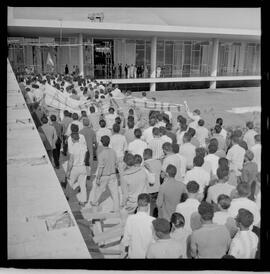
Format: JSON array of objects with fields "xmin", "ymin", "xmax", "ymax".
[{"xmin": 229, "ymin": 208, "xmax": 259, "ymax": 259}]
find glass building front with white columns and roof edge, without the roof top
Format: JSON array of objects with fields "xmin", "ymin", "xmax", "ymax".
[{"xmin": 8, "ymin": 8, "xmax": 261, "ymax": 91}]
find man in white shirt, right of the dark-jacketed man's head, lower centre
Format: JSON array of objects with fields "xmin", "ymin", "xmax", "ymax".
[{"xmin": 184, "ymin": 156, "xmax": 210, "ymax": 194}]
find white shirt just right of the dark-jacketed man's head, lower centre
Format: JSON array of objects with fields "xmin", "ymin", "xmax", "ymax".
[{"xmin": 184, "ymin": 166, "xmax": 210, "ymax": 193}]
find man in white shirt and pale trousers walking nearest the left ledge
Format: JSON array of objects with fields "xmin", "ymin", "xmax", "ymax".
[{"xmin": 66, "ymin": 132, "xmax": 87, "ymax": 205}]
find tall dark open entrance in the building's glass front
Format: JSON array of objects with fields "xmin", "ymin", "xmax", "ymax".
[{"xmin": 94, "ymin": 39, "xmax": 113, "ymax": 79}]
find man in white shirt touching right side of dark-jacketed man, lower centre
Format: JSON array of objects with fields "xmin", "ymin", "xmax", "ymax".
[{"xmin": 175, "ymin": 181, "xmax": 202, "ymax": 232}]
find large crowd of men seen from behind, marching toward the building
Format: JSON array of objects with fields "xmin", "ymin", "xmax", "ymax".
[{"xmin": 17, "ymin": 71, "xmax": 261, "ymax": 259}]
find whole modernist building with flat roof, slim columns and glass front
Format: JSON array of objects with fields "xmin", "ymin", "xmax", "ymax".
[{"xmin": 8, "ymin": 7, "xmax": 261, "ymax": 91}]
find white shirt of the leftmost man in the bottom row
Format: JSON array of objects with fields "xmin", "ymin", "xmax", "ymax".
[{"xmin": 122, "ymin": 211, "xmax": 155, "ymax": 259}]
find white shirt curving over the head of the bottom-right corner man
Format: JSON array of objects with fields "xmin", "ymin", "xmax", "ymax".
[{"xmin": 228, "ymin": 197, "xmax": 261, "ymax": 225}]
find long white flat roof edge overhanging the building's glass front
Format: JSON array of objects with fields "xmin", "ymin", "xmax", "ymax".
[{"xmin": 7, "ymin": 19, "xmax": 261, "ymax": 41}]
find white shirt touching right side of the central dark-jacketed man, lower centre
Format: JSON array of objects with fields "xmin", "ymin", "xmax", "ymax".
[{"xmin": 175, "ymin": 198, "xmax": 200, "ymax": 232}]
